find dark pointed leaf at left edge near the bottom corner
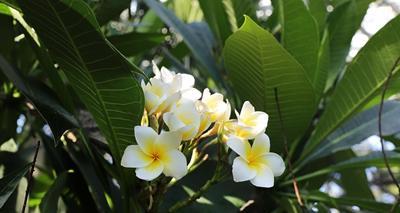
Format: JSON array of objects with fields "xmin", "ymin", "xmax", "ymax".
[{"xmin": 0, "ymin": 164, "xmax": 31, "ymax": 208}]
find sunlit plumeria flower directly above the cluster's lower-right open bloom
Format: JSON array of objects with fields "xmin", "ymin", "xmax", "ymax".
[{"xmin": 234, "ymin": 101, "xmax": 268, "ymax": 139}]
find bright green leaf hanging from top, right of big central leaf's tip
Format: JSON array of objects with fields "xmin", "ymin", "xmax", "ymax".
[{"xmin": 280, "ymin": 0, "xmax": 321, "ymax": 98}]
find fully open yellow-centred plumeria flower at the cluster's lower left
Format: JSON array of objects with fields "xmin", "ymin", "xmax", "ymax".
[{"xmin": 121, "ymin": 126, "xmax": 187, "ymax": 181}]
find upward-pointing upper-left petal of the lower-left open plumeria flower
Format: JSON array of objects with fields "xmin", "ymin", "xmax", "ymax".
[{"xmin": 135, "ymin": 126, "xmax": 158, "ymax": 154}]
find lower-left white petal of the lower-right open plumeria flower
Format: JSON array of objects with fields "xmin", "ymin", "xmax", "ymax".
[{"xmin": 232, "ymin": 157, "xmax": 257, "ymax": 182}]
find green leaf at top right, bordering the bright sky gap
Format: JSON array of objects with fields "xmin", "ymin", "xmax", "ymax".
[{"xmin": 328, "ymin": 0, "xmax": 373, "ymax": 86}]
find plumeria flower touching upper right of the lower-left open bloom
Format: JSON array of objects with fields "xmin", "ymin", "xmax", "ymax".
[{"xmin": 163, "ymin": 101, "xmax": 201, "ymax": 141}]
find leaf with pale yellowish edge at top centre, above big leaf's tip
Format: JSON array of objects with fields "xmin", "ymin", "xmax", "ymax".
[{"xmin": 199, "ymin": 0, "xmax": 237, "ymax": 47}]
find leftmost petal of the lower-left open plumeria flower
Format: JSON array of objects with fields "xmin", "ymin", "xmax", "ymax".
[{"xmin": 121, "ymin": 145, "xmax": 153, "ymax": 168}]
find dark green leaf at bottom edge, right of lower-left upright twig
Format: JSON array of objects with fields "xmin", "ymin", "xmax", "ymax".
[{"xmin": 40, "ymin": 172, "xmax": 68, "ymax": 213}]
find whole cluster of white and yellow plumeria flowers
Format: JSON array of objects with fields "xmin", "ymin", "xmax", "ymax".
[{"xmin": 121, "ymin": 64, "xmax": 285, "ymax": 187}]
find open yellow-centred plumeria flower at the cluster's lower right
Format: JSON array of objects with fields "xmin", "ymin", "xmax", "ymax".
[{"xmin": 227, "ymin": 133, "xmax": 285, "ymax": 188}]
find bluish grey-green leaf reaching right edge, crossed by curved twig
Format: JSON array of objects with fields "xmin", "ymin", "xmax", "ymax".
[{"xmin": 304, "ymin": 101, "xmax": 400, "ymax": 163}]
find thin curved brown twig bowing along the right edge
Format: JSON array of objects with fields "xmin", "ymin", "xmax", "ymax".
[{"xmin": 378, "ymin": 57, "xmax": 400, "ymax": 212}]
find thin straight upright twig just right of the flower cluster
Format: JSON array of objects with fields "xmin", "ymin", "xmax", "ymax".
[{"xmin": 274, "ymin": 87, "xmax": 304, "ymax": 206}]
